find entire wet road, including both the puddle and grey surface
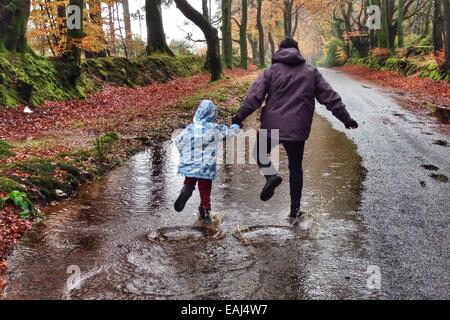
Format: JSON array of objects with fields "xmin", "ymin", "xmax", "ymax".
[{"xmin": 6, "ymin": 70, "xmax": 450, "ymax": 299}]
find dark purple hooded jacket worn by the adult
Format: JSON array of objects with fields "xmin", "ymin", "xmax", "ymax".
[{"xmin": 238, "ymin": 48, "xmax": 351, "ymax": 141}]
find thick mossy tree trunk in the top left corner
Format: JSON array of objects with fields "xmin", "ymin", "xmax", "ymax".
[{"xmin": 0, "ymin": 0, "xmax": 30, "ymax": 53}]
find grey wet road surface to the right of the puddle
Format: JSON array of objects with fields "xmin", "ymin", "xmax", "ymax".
[{"xmin": 317, "ymin": 70, "xmax": 450, "ymax": 299}]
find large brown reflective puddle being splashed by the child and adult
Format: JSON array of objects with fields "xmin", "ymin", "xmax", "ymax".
[{"xmin": 6, "ymin": 113, "xmax": 371, "ymax": 299}]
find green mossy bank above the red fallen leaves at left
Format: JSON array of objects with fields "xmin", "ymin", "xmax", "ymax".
[{"xmin": 0, "ymin": 50, "xmax": 203, "ymax": 107}]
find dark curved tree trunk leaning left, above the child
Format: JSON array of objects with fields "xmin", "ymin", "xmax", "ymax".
[{"xmin": 174, "ymin": 0, "xmax": 222, "ymax": 81}]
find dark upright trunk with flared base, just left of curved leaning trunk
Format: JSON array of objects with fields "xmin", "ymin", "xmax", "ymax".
[{"xmin": 145, "ymin": 0, "xmax": 174, "ymax": 56}]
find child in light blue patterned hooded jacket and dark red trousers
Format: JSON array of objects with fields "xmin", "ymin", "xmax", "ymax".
[{"xmin": 175, "ymin": 100, "xmax": 240, "ymax": 223}]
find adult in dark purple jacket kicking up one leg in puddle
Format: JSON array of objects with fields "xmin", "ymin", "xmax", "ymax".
[{"xmin": 233, "ymin": 38, "xmax": 358, "ymax": 219}]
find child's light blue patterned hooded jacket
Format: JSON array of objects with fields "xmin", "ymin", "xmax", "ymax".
[{"xmin": 175, "ymin": 100, "xmax": 240, "ymax": 180}]
